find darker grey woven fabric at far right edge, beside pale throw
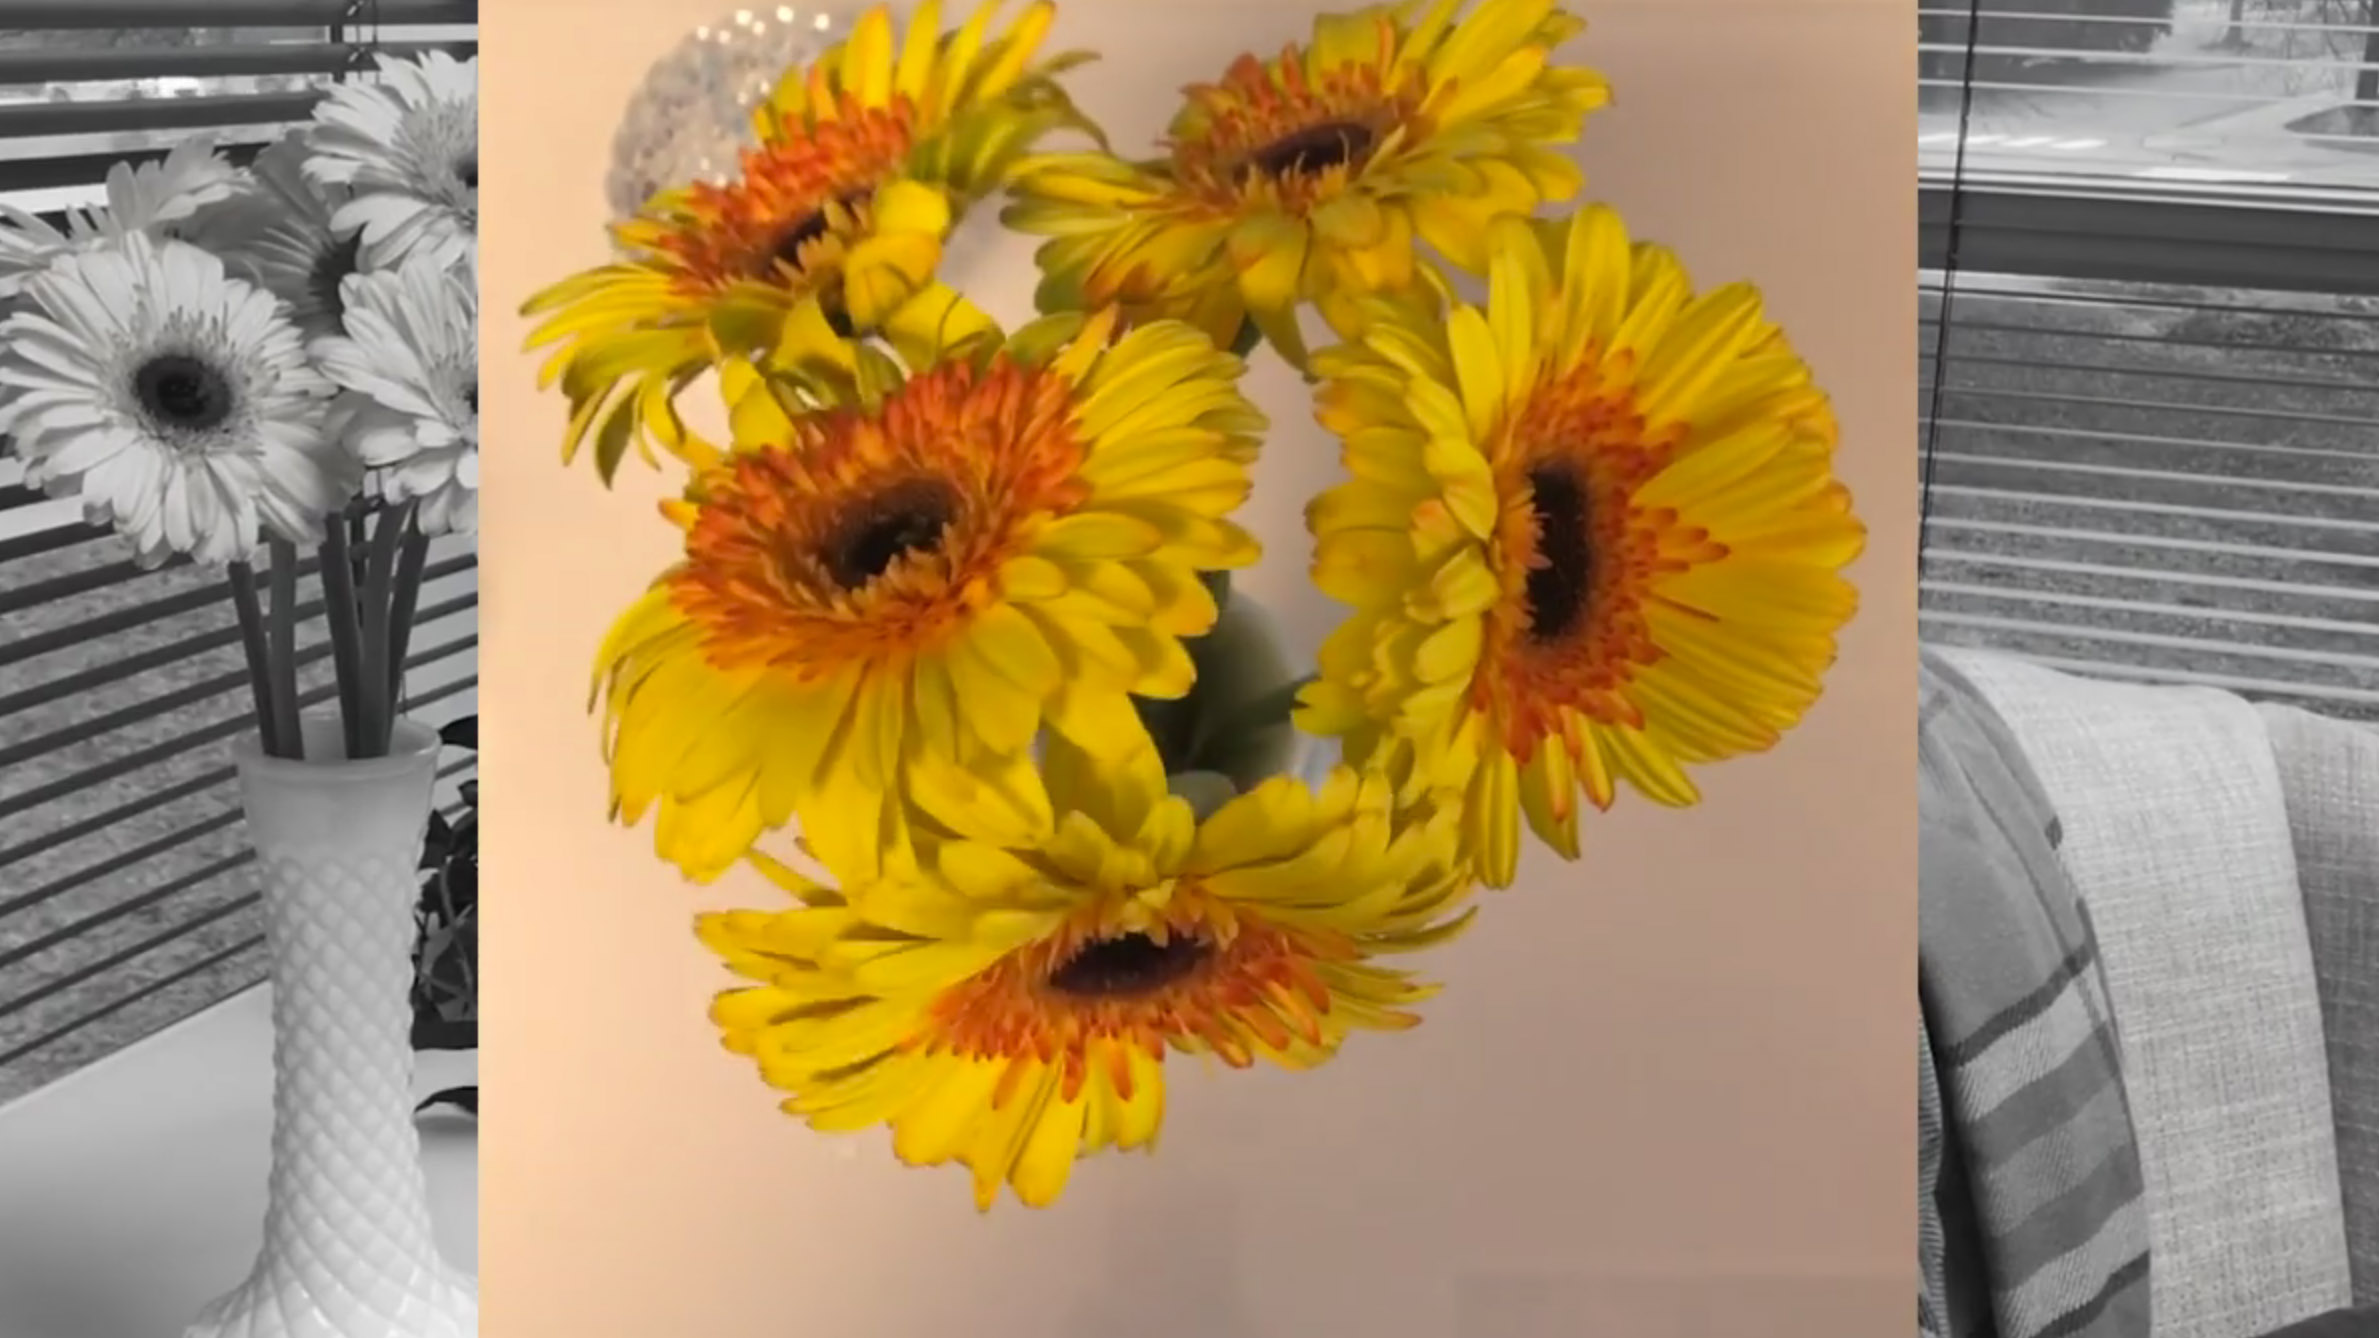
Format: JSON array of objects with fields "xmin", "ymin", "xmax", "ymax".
[{"xmin": 2262, "ymin": 707, "xmax": 2379, "ymax": 1304}]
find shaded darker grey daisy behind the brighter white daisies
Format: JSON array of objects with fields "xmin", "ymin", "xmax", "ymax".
[{"xmin": 186, "ymin": 136, "xmax": 362, "ymax": 340}]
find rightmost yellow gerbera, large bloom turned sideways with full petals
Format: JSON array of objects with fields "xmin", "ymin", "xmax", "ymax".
[{"xmin": 1299, "ymin": 207, "xmax": 1865, "ymax": 886}]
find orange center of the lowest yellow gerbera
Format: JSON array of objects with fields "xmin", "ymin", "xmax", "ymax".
[{"xmin": 909, "ymin": 886, "xmax": 1356, "ymax": 1100}]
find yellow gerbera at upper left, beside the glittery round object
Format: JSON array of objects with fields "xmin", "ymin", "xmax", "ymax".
[{"xmin": 523, "ymin": 0, "xmax": 1087, "ymax": 481}]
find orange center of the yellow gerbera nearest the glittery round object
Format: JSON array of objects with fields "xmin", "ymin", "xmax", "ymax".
[{"xmin": 659, "ymin": 95, "xmax": 918, "ymax": 293}]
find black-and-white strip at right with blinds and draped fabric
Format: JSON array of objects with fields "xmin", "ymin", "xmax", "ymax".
[{"xmin": 1915, "ymin": 0, "xmax": 2379, "ymax": 1338}]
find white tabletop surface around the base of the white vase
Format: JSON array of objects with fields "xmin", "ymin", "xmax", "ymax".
[{"xmin": 0, "ymin": 988, "xmax": 478, "ymax": 1338}]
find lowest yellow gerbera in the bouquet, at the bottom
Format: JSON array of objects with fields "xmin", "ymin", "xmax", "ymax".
[{"xmin": 699, "ymin": 736, "xmax": 1468, "ymax": 1209}]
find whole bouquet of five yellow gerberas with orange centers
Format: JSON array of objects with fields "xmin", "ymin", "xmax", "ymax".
[{"xmin": 528, "ymin": 0, "xmax": 1863, "ymax": 1207}]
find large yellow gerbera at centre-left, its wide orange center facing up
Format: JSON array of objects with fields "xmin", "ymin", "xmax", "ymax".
[{"xmin": 597, "ymin": 312, "xmax": 1266, "ymax": 881}]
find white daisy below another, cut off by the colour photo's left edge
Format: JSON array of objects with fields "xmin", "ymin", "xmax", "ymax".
[{"xmin": 314, "ymin": 257, "xmax": 478, "ymax": 533}]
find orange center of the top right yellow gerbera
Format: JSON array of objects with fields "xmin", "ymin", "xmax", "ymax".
[{"xmin": 1173, "ymin": 37, "xmax": 1427, "ymax": 210}]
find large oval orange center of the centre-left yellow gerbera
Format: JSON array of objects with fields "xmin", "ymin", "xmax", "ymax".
[{"xmin": 668, "ymin": 355, "xmax": 1085, "ymax": 679}]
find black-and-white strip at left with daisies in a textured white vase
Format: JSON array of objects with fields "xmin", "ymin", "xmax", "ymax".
[{"xmin": 0, "ymin": 0, "xmax": 481, "ymax": 1338}]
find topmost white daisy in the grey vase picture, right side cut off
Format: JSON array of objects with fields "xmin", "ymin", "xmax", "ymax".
[{"xmin": 307, "ymin": 50, "xmax": 478, "ymax": 269}]
